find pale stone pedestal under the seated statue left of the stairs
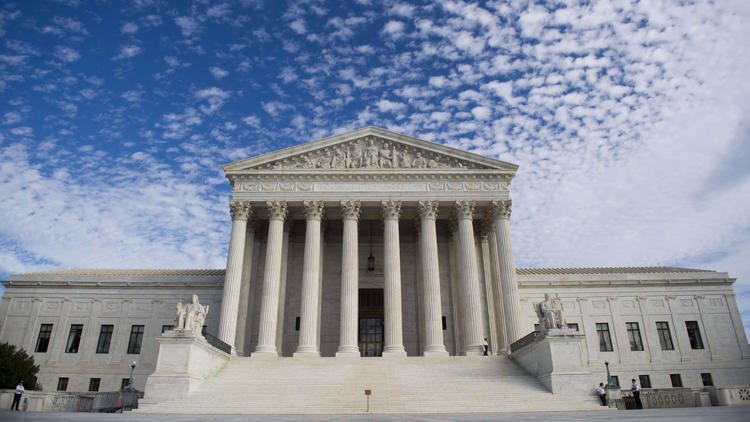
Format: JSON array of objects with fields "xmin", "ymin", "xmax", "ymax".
[{"xmin": 142, "ymin": 330, "xmax": 230, "ymax": 403}]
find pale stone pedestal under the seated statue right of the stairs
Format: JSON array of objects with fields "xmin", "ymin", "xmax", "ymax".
[{"xmin": 510, "ymin": 328, "xmax": 594, "ymax": 397}]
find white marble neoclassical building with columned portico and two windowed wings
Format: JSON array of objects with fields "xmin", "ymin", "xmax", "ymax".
[{"xmin": 0, "ymin": 127, "xmax": 750, "ymax": 413}]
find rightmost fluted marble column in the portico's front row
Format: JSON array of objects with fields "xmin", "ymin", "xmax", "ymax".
[{"xmin": 492, "ymin": 199, "xmax": 524, "ymax": 345}]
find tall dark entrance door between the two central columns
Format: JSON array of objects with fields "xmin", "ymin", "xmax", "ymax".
[{"xmin": 359, "ymin": 289, "xmax": 383, "ymax": 357}]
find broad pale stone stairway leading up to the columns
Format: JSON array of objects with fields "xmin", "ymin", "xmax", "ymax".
[{"xmin": 138, "ymin": 356, "xmax": 601, "ymax": 414}]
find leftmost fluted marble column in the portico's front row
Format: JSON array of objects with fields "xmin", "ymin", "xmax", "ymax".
[{"xmin": 219, "ymin": 200, "xmax": 252, "ymax": 354}]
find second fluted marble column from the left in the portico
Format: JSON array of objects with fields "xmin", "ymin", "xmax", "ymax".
[{"xmin": 253, "ymin": 201, "xmax": 288, "ymax": 356}]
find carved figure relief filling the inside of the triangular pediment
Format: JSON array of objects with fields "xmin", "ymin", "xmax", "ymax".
[{"xmin": 259, "ymin": 136, "xmax": 484, "ymax": 170}]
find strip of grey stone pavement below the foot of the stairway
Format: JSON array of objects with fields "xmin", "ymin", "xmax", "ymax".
[{"xmin": 0, "ymin": 406, "xmax": 750, "ymax": 422}]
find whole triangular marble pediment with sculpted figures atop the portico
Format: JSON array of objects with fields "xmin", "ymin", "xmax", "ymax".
[{"xmin": 224, "ymin": 127, "xmax": 518, "ymax": 174}]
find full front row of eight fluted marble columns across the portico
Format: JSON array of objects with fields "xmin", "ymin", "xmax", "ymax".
[{"xmin": 219, "ymin": 200, "xmax": 520, "ymax": 357}]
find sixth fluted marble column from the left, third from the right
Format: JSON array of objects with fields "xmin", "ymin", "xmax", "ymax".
[{"xmin": 418, "ymin": 201, "xmax": 448, "ymax": 356}]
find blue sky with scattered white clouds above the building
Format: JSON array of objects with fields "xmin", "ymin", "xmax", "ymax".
[{"xmin": 0, "ymin": 0, "xmax": 750, "ymax": 336}]
